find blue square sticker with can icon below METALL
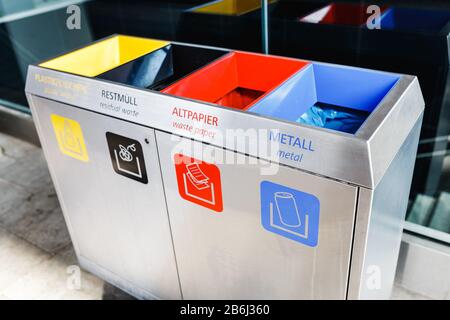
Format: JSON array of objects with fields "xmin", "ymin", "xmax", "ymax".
[{"xmin": 261, "ymin": 181, "xmax": 320, "ymax": 247}]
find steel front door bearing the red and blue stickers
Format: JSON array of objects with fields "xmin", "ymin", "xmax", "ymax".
[{"xmin": 156, "ymin": 131, "xmax": 357, "ymax": 299}]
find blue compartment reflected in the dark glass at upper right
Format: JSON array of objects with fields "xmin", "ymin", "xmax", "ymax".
[{"xmin": 381, "ymin": 7, "xmax": 450, "ymax": 32}]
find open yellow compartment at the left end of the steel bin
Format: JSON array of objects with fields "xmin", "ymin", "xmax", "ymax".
[{"xmin": 39, "ymin": 35, "xmax": 170, "ymax": 77}]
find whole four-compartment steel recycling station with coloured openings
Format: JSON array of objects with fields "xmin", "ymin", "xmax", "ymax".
[{"xmin": 26, "ymin": 35, "xmax": 424, "ymax": 299}]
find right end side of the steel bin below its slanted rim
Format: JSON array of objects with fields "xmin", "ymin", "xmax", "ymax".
[{"xmin": 348, "ymin": 116, "xmax": 422, "ymax": 299}]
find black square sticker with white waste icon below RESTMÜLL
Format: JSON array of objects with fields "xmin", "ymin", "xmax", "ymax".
[{"xmin": 106, "ymin": 132, "xmax": 148, "ymax": 183}]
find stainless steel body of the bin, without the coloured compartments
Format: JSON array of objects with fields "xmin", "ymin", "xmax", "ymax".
[{"xmin": 26, "ymin": 38, "xmax": 424, "ymax": 299}]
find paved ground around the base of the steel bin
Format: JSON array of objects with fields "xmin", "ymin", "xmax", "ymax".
[{"xmin": 0, "ymin": 133, "xmax": 426, "ymax": 300}]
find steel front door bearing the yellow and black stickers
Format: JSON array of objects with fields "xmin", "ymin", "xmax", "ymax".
[{"xmin": 31, "ymin": 96, "xmax": 181, "ymax": 299}]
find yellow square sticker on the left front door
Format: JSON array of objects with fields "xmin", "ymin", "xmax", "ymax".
[{"xmin": 51, "ymin": 114, "xmax": 89, "ymax": 162}]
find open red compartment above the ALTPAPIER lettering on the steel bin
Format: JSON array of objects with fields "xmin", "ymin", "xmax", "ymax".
[{"xmin": 162, "ymin": 52, "xmax": 308, "ymax": 110}]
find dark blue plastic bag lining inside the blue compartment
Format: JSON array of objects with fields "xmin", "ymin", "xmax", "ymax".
[{"xmin": 297, "ymin": 102, "xmax": 368, "ymax": 133}]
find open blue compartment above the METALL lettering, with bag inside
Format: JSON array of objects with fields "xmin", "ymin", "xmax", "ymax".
[{"xmin": 249, "ymin": 63, "xmax": 400, "ymax": 133}]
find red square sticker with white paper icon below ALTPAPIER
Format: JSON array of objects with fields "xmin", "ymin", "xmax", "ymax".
[{"xmin": 174, "ymin": 154, "xmax": 223, "ymax": 212}]
